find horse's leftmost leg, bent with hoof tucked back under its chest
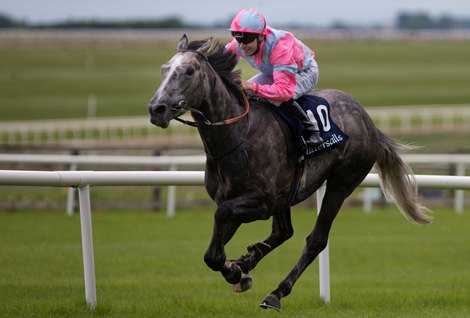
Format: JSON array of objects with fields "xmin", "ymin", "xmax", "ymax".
[{"xmin": 204, "ymin": 198, "xmax": 269, "ymax": 284}]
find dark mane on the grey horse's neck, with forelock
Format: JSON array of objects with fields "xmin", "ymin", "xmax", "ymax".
[{"xmin": 188, "ymin": 40, "xmax": 241, "ymax": 93}]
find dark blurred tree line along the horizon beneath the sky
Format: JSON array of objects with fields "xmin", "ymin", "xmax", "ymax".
[{"xmin": 0, "ymin": 12, "xmax": 470, "ymax": 30}]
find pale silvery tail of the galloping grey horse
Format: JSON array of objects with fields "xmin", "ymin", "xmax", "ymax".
[{"xmin": 376, "ymin": 131, "xmax": 432, "ymax": 224}]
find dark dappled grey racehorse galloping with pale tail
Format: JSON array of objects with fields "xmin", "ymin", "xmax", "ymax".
[{"xmin": 148, "ymin": 35, "xmax": 431, "ymax": 310}]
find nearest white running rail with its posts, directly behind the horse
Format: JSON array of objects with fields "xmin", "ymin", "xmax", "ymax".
[{"xmin": 0, "ymin": 170, "xmax": 470, "ymax": 308}]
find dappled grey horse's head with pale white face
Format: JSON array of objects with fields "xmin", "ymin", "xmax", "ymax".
[{"xmin": 148, "ymin": 35, "xmax": 212, "ymax": 128}]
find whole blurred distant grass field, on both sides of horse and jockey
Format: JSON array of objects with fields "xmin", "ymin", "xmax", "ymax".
[{"xmin": 0, "ymin": 34, "xmax": 470, "ymax": 121}]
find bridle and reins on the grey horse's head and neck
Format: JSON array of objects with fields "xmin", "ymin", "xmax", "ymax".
[{"xmin": 172, "ymin": 49, "xmax": 250, "ymax": 127}]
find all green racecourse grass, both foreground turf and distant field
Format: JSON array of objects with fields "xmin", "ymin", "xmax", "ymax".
[{"xmin": 0, "ymin": 31, "xmax": 470, "ymax": 318}]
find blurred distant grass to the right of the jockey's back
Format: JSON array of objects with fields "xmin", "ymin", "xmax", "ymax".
[{"xmin": 308, "ymin": 40, "xmax": 470, "ymax": 107}]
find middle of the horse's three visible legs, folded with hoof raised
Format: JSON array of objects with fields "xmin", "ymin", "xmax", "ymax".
[{"xmin": 233, "ymin": 208, "xmax": 294, "ymax": 293}]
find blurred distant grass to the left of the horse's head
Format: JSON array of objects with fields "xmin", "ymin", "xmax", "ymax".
[{"xmin": 0, "ymin": 48, "xmax": 169, "ymax": 120}]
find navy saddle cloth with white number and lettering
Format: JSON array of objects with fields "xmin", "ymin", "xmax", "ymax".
[{"xmin": 271, "ymin": 95, "xmax": 349, "ymax": 159}]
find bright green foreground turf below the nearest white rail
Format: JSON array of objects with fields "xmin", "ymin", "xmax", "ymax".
[{"xmin": 0, "ymin": 207, "xmax": 470, "ymax": 317}]
